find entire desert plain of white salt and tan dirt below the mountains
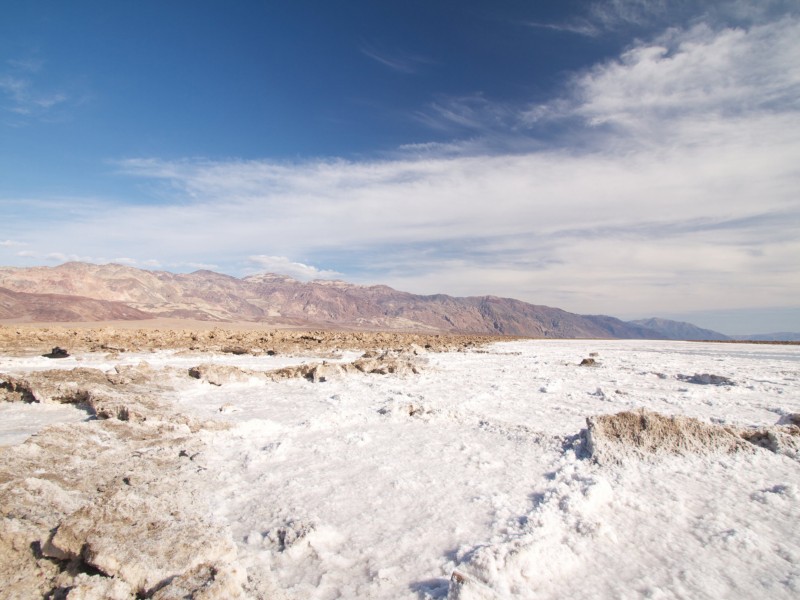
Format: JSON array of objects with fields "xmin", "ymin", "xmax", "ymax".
[{"xmin": 0, "ymin": 322, "xmax": 800, "ymax": 600}]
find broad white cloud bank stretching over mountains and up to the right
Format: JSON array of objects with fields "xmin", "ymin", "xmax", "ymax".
[{"xmin": 4, "ymin": 13, "xmax": 800, "ymax": 328}]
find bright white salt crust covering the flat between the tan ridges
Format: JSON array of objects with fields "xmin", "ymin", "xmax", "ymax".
[{"xmin": 0, "ymin": 341, "xmax": 800, "ymax": 600}]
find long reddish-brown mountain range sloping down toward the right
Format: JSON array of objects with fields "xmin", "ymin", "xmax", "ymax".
[{"xmin": 0, "ymin": 263, "xmax": 662, "ymax": 338}]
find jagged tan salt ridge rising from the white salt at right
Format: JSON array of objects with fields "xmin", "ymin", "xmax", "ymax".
[{"xmin": 583, "ymin": 409, "xmax": 753, "ymax": 463}]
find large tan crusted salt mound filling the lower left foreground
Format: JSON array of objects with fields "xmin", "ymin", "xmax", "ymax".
[{"xmin": 0, "ymin": 370, "xmax": 246, "ymax": 600}]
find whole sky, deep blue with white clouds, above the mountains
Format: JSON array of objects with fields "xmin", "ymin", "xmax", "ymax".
[{"xmin": 0, "ymin": 0, "xmax": 800, "ymax": 334}]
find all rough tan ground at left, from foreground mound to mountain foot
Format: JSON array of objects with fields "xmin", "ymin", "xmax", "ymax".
[{"xmin": 0, "ymin": 327, "xmax": 488, "ymax": 600}]
